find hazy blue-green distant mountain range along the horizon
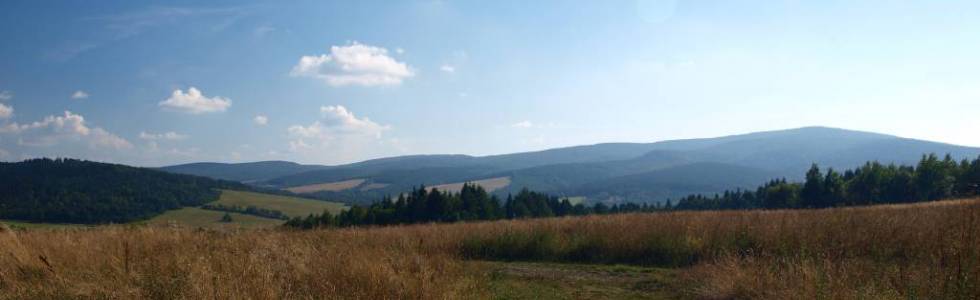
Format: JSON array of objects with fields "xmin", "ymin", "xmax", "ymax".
[{"xmin": 162, "ymin": 127, "xmax": 980, "ymax": 203}]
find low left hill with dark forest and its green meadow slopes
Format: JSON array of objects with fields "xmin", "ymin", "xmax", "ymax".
[{"xmin": 0, "ymin": 159, "xmax": 344, "ymax": 225}]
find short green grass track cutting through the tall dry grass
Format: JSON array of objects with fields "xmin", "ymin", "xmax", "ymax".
[{"xmin": 472, "ymin": 262, "xmax": 685, "ymax": 299}]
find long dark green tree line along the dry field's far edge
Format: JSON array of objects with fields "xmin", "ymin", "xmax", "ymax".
[{"xmin": 286, "ymin": 154, "xmax": 980, "ymax": 229}]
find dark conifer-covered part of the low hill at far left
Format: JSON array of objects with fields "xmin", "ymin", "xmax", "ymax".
[{"xmin": 0, "ymin": 159, "xmax": 248, "ymax": 224}]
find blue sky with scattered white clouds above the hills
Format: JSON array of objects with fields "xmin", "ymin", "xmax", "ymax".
[{"xmin": 0, "ymin": 0, "xmax": 980, "ymax": 166}]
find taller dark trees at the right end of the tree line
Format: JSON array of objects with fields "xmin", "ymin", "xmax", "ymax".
[{"xmin": 670, "ymin": 154, "xmax": 980, "ymax": 210}]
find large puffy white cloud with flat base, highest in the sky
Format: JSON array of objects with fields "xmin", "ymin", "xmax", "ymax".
[{"xmin": 290, "ymin": 42, "xmax": 415, "ymax": 86}]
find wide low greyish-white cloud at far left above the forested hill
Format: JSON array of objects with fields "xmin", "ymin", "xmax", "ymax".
[{"xmin": 0, "ymin": 111, "xmax": 133, "ymax": 149}]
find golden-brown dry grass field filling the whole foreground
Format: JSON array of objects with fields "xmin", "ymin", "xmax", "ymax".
[{"xmin": 0, "ymin": 200, "xmax": 980, "ymax": 299}]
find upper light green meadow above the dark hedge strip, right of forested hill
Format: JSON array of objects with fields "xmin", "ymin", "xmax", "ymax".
[{"xmin": 212, "ymin": 190, "xmax": 344, "ymax": 217}]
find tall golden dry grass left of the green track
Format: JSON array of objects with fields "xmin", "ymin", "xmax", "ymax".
[{"xmin": 0, "ymin": 227, "xmax": 480, "ymax": 299}]
